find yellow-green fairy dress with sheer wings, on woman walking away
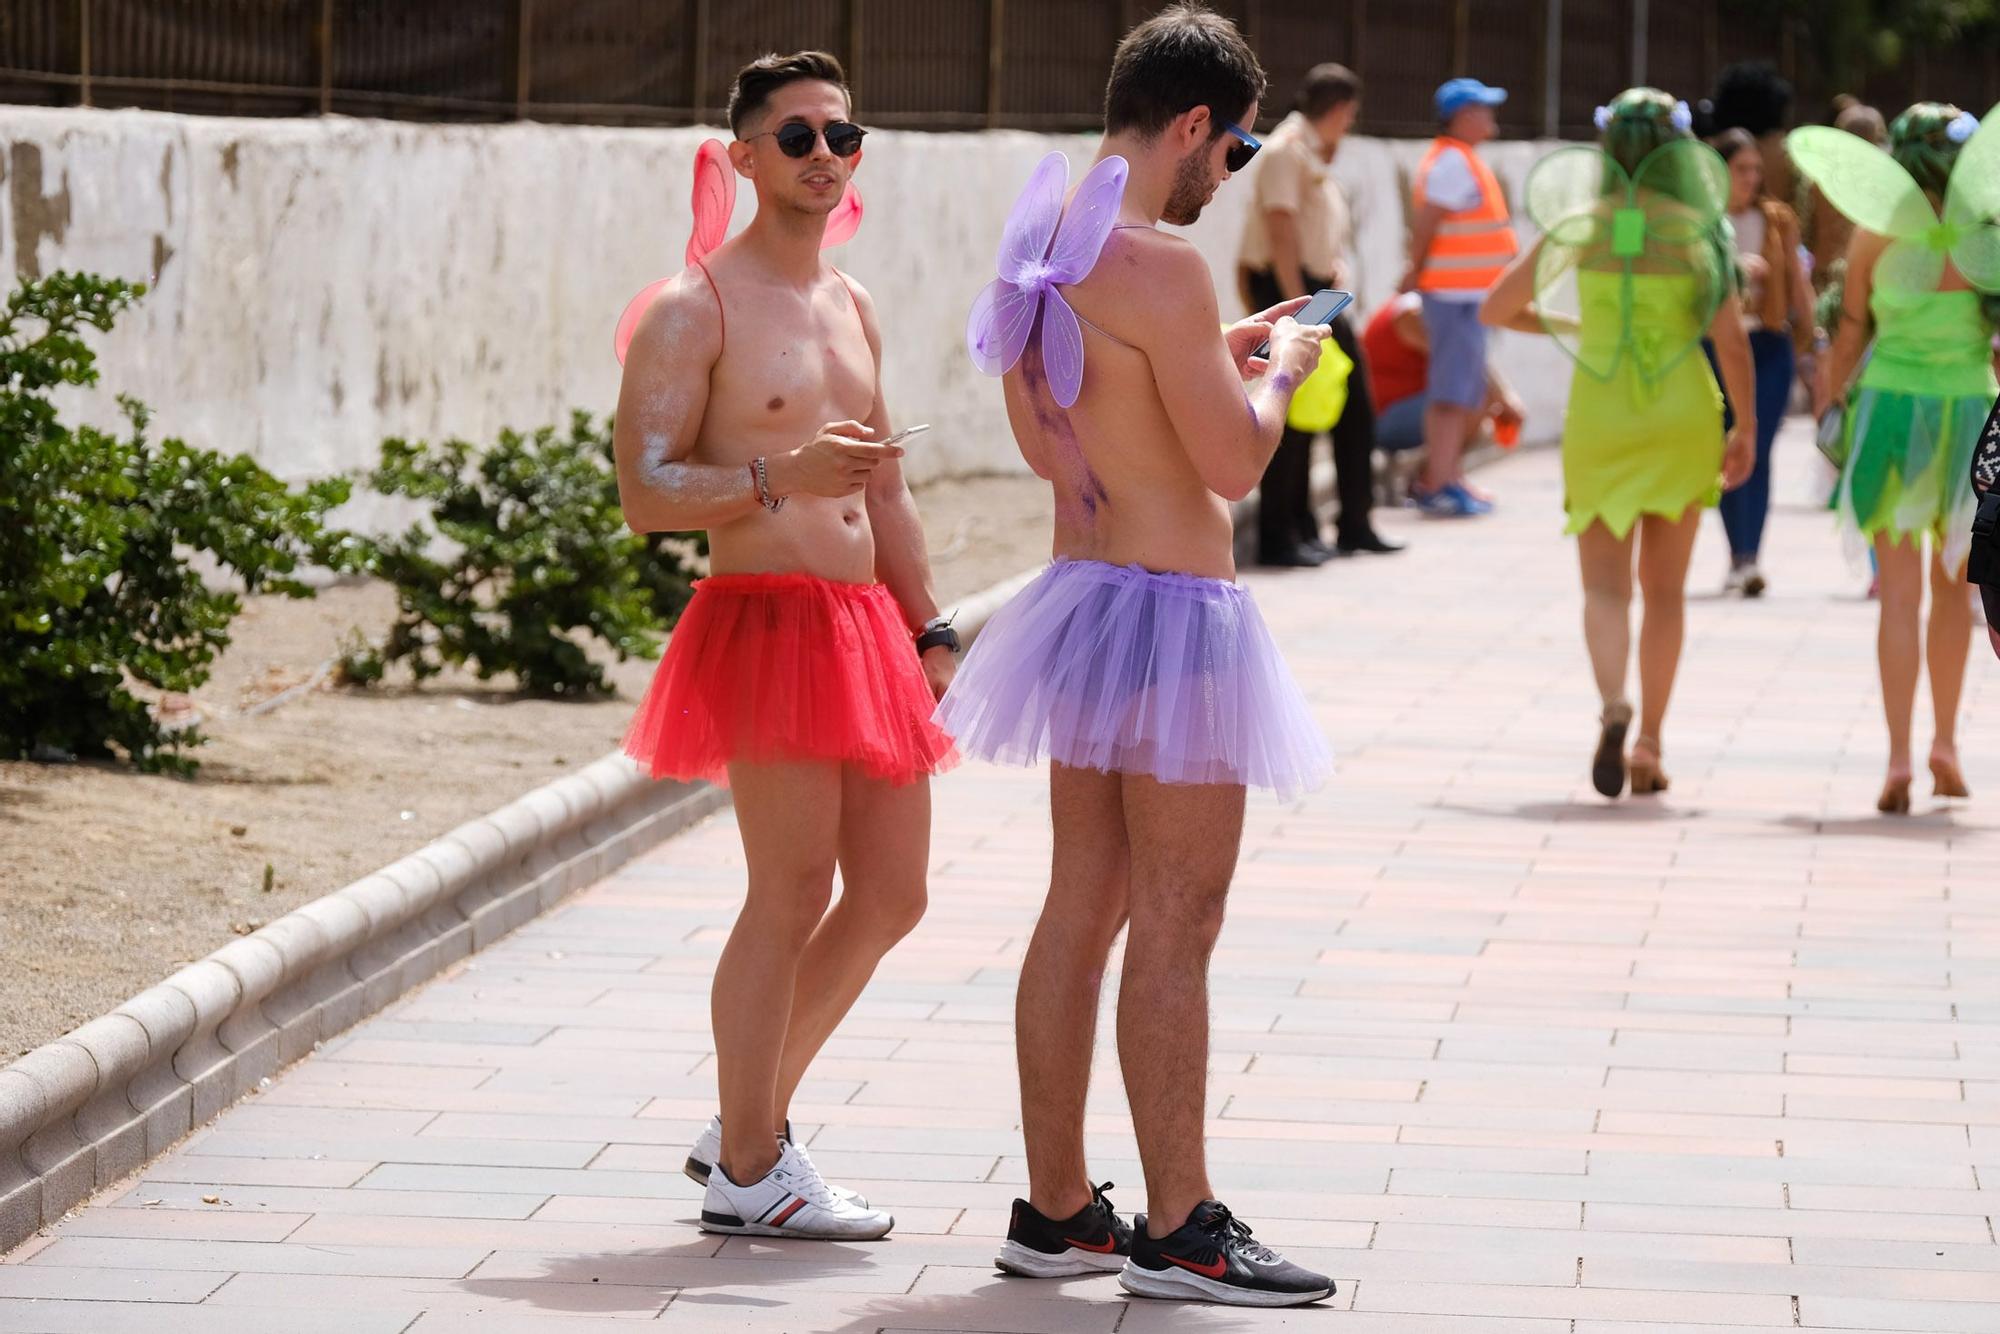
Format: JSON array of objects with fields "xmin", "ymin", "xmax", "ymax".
[{"xmin": 1526, "ymin": 138, "xmax": 1734, "ymax": 538}]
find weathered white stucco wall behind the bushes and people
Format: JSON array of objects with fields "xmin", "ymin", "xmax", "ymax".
[{"xmin": 0, "ymin": 106, "xmax": 1568, "ymax": 520}]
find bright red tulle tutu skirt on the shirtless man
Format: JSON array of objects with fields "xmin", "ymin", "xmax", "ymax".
[{"xmin": 624, "ymin": 574, "xmax": 958, "ymax": 786}]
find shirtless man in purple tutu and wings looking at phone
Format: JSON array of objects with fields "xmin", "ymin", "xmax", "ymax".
[{"xmin": 938, "ymin": 6, "xmax": 1334, "ymax": 1306}]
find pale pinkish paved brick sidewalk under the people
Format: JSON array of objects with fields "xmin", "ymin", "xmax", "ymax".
[{"xmin": 0, "ymin": 438, "xmax": 2000, "ymax": 1334}]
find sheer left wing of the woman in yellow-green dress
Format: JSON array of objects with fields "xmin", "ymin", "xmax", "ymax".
[{"xmin": 1522, "ymin": 144, "xmax": 1632, "ymax": 380}]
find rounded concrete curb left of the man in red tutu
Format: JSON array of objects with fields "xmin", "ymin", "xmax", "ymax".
[{"xmin": 0, "ymin": 754, "xmax": 728, "ymax": 1252}]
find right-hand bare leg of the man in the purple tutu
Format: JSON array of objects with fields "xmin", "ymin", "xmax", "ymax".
[{"xmin": 1118, "ymin": 774, "xmax": 1244, "ymax": 1236}]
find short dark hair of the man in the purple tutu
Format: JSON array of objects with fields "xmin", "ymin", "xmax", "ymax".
[{"xmin": 1104, "ymin": 4, "xmax": 1264, "ymax": 138}]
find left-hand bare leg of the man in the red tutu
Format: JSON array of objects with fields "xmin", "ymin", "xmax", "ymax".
[{"xmin": 710, "ymin": 762, "xmax": 842, "ymax": 1184}]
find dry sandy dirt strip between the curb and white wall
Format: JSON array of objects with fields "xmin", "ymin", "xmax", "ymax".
[{"xmin": 0, "ymin": 478, "xmax": 1048, "ymax": 1064}]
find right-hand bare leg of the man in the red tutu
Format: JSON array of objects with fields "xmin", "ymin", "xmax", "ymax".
[{"xmin": 772, "ymin": 766, "xmax": 930, "ymax": 1132}]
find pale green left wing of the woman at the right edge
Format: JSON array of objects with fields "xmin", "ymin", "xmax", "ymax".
[{"xmin": 1784, "ymin": 126, "xmax": 1958, "ymax": 292}]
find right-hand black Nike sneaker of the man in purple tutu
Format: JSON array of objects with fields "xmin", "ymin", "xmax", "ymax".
[{"xmin": 1118, "ymin": 1200, "xmax": 1334, "ymax": 1306}]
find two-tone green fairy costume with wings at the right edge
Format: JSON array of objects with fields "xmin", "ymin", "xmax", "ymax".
[{"xmin": 1786, "ymin": 110, "xmax": 2000, "ymax": 568}]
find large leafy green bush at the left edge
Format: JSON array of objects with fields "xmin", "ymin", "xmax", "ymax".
[{"xmin": 0, "ymin": 272, "xmax": 348, "ymax": 774}]
